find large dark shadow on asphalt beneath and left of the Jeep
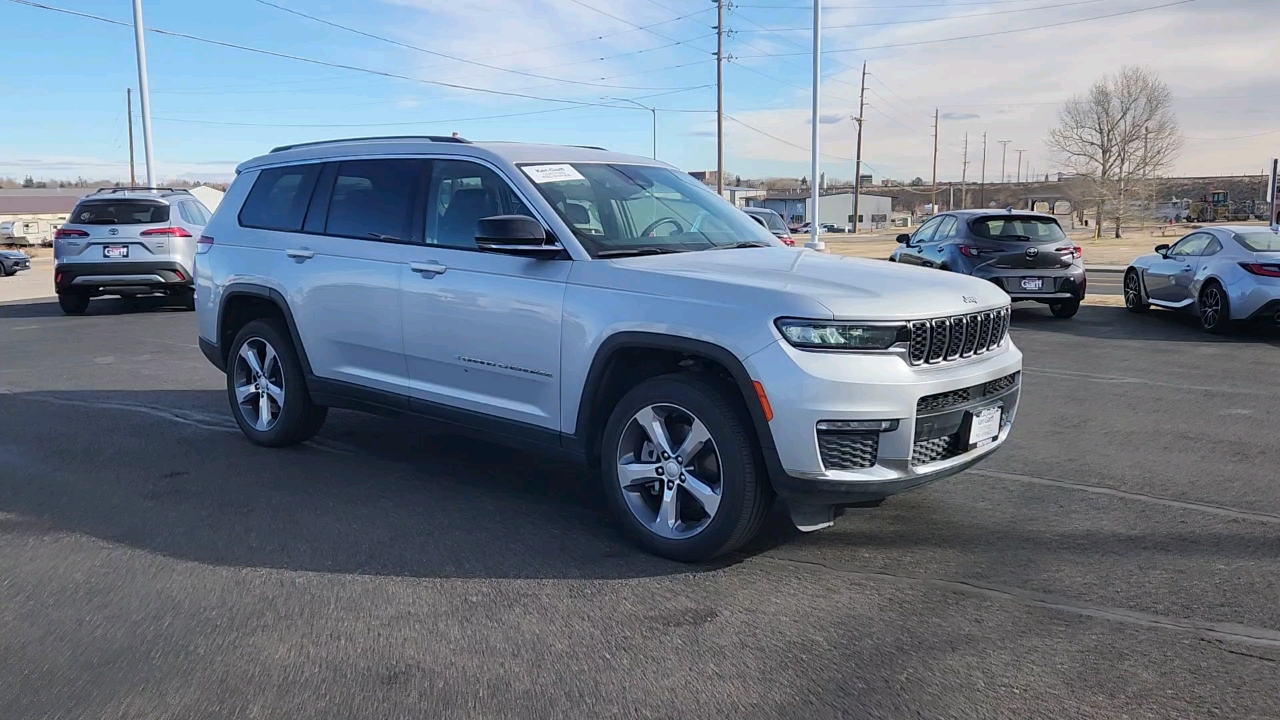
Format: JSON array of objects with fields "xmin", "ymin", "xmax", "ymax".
[{"xmin": 0, "ymin": 391, "xmax": 736, "ymax": 579}]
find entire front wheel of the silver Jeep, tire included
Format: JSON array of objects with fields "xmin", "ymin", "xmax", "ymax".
[{"xmin": 600, "ymin": 373, "xmax": 773, "ymax": 562}]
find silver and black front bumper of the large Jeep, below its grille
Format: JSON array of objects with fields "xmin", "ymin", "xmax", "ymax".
[{"xmin": 748, "ymin": 338, "xmax": 1023, "ymax": 514}]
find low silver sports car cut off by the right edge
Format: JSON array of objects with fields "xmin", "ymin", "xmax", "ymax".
[{"xmin": 1124, "ymin": 225, "xmax": 1280, "ymax": 333}]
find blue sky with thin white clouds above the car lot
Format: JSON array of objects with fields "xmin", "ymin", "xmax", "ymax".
[{"xmin": 0, "ymin": 0, "xmax": 1280, "ymax": 181}]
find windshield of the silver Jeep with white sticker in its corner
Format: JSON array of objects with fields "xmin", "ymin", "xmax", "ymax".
[{"xmin": 520, "ymin": 163, "xmax": 778, "ymax": 256}]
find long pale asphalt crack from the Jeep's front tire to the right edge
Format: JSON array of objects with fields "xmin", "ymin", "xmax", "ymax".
[{"xmin": 755, "ymin": 555, "xmax": 1280, "ymax": 650}]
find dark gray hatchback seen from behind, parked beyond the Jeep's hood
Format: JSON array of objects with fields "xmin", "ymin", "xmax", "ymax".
[{"xmin": 890, "ymin": 210, "xmax": 1087, "ymax": 318}]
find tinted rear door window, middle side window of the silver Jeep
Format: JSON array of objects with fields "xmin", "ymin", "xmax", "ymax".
[{"xmin": 325, "ymin": 160, "xmax": 422, "ymax": 242}]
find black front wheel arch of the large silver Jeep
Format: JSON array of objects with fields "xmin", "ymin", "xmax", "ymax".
[{"xmin": 564, "ymin": 332, "xmax": 781, "ymax": 474}]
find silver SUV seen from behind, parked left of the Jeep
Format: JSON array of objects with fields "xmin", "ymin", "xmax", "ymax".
[{"xmin": 54, "ymin": 187, "xmax": 210, "ymax": 315}]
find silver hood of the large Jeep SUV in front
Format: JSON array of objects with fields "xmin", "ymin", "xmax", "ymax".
[{"xmin": 599, "ymin": 247, "xmax": 1009, "ymax": 320}]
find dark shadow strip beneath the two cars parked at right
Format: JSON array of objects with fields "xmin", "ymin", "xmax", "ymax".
[{"xmin": 1012, "ymin": 305, "xmax": 1280, "ymax": 343}]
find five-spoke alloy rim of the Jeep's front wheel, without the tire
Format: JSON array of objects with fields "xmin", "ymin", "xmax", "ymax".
[{"xmin": 616, "ymin": 404, "xmax": 723, "ymax": 539}]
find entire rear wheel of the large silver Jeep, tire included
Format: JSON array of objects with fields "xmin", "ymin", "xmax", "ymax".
[{"xmin": 227, "ymin": 320, "xmax": 329, "ymax": 447}]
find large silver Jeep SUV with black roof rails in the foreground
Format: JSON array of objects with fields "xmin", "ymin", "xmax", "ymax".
[{"xmin": 196, "ymin": 137, "xmax": 1021, "ymax": 560}]
